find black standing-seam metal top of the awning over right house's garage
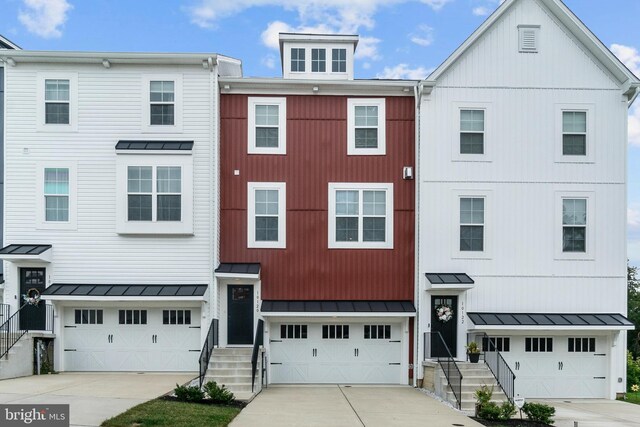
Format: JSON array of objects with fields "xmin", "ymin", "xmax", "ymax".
[{"xmin": 467, "ymin": 313, "xmax": 634, "ymax": 327}]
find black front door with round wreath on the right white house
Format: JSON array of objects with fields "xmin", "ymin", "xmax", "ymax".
[{"xmin": 431, "ymin": 296, "xmax": 458, "ymax": 357}]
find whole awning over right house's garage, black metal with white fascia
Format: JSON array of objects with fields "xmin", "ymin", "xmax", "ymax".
[{"xmin": 467, "ymin": 313, "xmax": 635, "ymax": 330}]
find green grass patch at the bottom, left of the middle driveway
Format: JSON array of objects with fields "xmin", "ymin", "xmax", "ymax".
[{"xmin": 102, "ymin": 399, "xmax": 240, "ymax": 427}]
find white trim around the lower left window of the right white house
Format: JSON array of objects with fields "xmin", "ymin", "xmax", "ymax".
[{"xmin": 451, "ymin": 190, "xmax": 493, "ymax": 259}]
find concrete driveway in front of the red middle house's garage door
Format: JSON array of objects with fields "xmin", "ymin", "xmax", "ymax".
[{"xmin": 231, "ymin": 385, "xmax": 480, "ymax": 427}]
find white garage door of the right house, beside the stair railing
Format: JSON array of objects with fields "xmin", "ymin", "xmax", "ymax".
[{"xmin": 501, "ymin": 335, "xmax": 609, "ymax": 398}]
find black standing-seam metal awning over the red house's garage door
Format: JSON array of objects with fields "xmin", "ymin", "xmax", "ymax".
[{"xmin": 261, "ymin": 300, "xmax": 416, "ymax": 313}]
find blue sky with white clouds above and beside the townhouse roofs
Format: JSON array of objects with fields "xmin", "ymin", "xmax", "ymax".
[{"xmin": 0, "ymin": 0, "xmax": 640, "ymax": 266}]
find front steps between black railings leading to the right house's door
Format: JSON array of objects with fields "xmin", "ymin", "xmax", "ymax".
[{"xmin": 439, "ymin": 362, "xmax": 507, "ymax": 415}]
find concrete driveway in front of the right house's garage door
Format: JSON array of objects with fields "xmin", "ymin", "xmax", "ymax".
[{"xmin": 536, "ymin": 399, "xmax": 640, "ymax": 427}]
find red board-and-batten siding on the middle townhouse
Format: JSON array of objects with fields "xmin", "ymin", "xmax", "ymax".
[{"xmin": 220, "ymin": 95, "xmax": 415, "ymax": 301}]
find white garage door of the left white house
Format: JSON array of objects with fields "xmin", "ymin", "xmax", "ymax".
[{"xmin": 62, "ymin": 308, "xmax": 200, "ymax": 371}]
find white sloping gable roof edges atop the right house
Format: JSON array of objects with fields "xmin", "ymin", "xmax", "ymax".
[{"xmin": 425, "ymin": 0, "xmax": 640, "ymax": 93}]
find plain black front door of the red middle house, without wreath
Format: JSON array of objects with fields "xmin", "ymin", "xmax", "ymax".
[{"xmin": 227, "ymin": 285, "xmax": 253, "ymax": 345}]
